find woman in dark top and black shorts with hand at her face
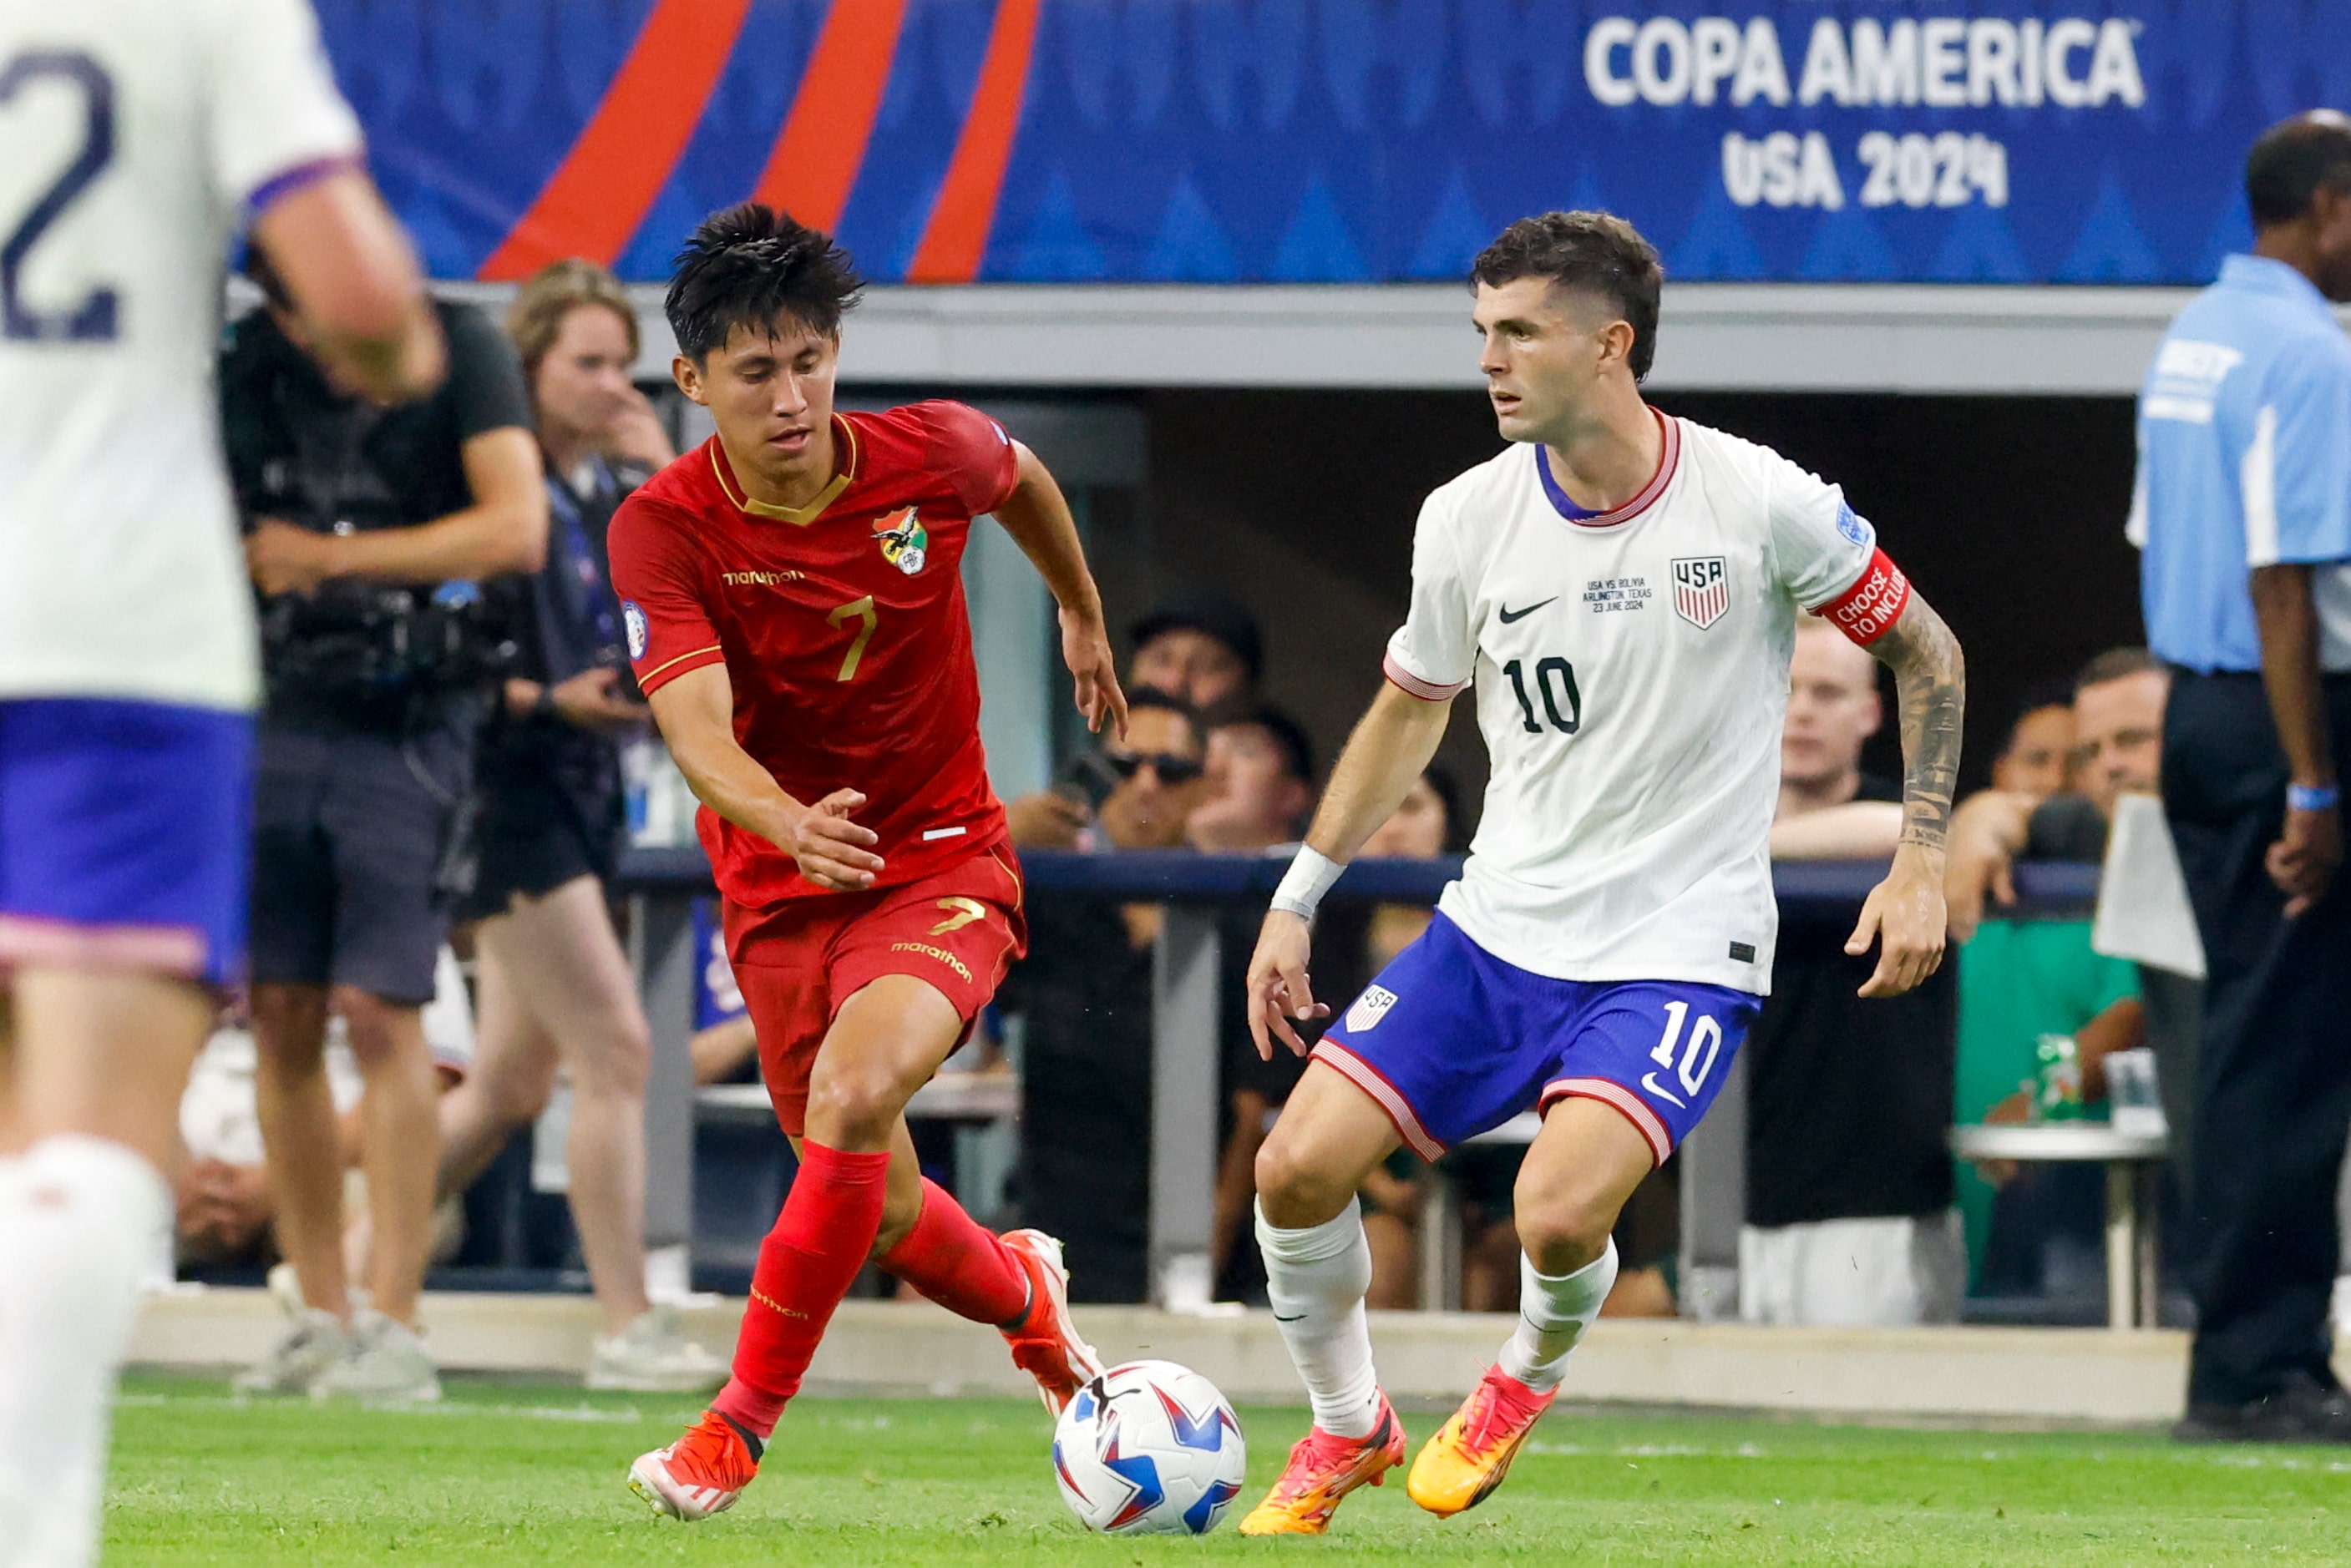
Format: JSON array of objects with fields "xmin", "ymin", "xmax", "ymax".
[{"xmin": 423, "ymin": 261, "xmax": 727, "ymax": 1392}]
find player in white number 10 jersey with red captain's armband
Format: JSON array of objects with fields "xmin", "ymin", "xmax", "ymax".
[{"xmin": 1241, "ymin": 211, "xmax": 1963, "ymax": 1535}]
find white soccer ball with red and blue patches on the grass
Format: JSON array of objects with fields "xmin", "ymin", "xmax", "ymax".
[{"xmin": 1053, "ymin": 1361, "xmax": 1249, "ymax": 1535}]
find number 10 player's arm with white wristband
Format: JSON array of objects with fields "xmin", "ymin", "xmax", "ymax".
[{"xmin": 1249, "ymin": 682, "xmax": 1453, "ymax": 1060}]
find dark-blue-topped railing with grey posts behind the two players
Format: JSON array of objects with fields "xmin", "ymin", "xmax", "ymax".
[{"xmin": 618, "ymin": 847, "xmax": 2097, "ymax": 1317}]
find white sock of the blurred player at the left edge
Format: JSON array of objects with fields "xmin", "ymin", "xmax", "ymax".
[{"xmin": 0, "ymin": 1136, "xmax": 171, "ymax": 1568}]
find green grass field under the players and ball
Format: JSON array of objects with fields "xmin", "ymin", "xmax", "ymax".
[{"xmin": 106, "ymin": 1375, "xmax": 2351, "ymax": 1568}]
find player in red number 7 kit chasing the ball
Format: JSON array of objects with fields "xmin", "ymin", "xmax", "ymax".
[{"xmin": 611, "ymin": 202, "xmax": 1126, "ymax": 1519}]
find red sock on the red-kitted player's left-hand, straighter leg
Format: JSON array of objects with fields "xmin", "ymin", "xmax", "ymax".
[{"xmin": 710, "ymin": 1138, "xmax": 889, "ymax": 1441}]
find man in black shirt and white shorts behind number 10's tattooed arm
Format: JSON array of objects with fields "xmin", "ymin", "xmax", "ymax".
[{"xmin": 1740, "ymin": 619, "xmax": 1965, "ymax": 1326}]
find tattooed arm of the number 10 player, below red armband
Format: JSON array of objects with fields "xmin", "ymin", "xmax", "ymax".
[{"xmin": 1846, "ymin": 593, "xmax": 1968, "ymax": 997}]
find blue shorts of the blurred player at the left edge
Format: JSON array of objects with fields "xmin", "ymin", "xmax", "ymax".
[{"xmin": 0, "ymin": 698, "xmax": 254, "ymax": 985}]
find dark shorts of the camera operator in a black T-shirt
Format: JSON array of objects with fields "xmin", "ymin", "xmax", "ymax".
[{"xmin": 251, "ymin": 717, "xmax": 475, "ymax": 1006}]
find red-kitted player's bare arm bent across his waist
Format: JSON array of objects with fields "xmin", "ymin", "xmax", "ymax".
[{"xmin": 651, "ymin": 665, "xmax": 882, "ymax": 893}]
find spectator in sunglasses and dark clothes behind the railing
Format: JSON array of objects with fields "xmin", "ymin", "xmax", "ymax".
[{"xmin": 997, "ymin": 689, "xmax": 1208, "ymax": 1302}]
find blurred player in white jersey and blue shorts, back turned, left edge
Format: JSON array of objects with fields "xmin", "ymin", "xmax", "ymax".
[{"xmin": 0, "ymin": 0, "xmax": 442, "ymax": 1568}]
